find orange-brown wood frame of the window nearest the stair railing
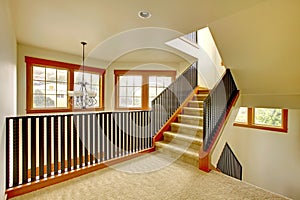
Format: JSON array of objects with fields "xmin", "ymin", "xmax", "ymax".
[{"xmin": 114, "ymin": 70, "xmax": 176, "ymax": 110}]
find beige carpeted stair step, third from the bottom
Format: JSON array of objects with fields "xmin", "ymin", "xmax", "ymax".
[{"xmin": 171, "ymin": 122, "xmax": 203, "ymax": 138}]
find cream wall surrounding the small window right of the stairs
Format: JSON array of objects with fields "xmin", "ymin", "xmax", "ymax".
[{"xmin": 211, "ymin": 99, "xmax": 300, "ymax": 199}]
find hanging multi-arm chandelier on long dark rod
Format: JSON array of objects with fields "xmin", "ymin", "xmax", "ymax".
[{"xmin": 68, "ymin": 42, "xmax": 97, "ymax": 109}]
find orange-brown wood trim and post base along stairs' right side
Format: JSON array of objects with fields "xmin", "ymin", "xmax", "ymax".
[{"xmin": 199, "ymin": 90, "xmax": 240, "ymax": 172}]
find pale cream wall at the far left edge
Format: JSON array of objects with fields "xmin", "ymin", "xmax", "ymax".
[{"xmin": 0, "ymin": 0, "xmax": 17, "ymax": 200}]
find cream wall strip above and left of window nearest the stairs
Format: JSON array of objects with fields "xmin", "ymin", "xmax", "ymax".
[{"xmin": 104, "ymin": 61, "xmax": 185, "ymax": 110}]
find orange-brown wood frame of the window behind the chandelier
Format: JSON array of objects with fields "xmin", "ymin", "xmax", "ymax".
[{"xmin": 25, "ymin": 56, "xmax": 105, "ymax": 114}]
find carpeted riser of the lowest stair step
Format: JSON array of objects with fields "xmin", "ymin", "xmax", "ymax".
[{"xmin": 156, "ymin": 147, "xmax": 199, "ymax": 167}]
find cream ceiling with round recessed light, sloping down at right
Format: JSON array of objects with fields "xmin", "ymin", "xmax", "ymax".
[{"xmin": 10, "ymin": 0, "xmax": 300, "ymax": 106}]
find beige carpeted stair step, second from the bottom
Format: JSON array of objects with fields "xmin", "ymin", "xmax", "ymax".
[{"xmin": 164, "ymin": 131, "xmax": 203, "ymax": 151}]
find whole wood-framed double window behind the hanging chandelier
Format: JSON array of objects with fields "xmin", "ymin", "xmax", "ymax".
[{"xmin": 25, "ymin": 57, "xmax": 105, "ymax": 113}]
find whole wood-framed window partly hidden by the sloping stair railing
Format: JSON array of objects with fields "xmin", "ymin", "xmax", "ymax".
[{"xmin": 115, "ymin": 70, "xmax": 176, "ymax": 110}]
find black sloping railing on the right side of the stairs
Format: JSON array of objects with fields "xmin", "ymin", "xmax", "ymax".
[{"xmin": 203, "ymin": 69, "xmax": 238, "ymax": 151}]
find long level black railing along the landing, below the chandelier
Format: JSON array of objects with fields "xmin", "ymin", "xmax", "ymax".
[{"xmin": 6, "ymin": 111, "xmax": 153, "ymax": 189}]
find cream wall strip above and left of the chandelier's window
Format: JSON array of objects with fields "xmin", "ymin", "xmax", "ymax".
[{"xmin": 17, "ymin": 44, "xmax": 106, "ymax": 115}]
